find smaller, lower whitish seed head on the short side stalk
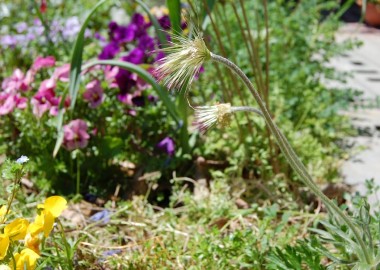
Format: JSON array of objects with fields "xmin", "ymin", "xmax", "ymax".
[{"xmin": 194, "ymin": 103, "xmax": 232, "ymax": 133}]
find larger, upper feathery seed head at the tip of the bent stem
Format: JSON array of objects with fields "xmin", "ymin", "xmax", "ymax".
[{"xmin": 155, "ymin": 34, "xmax": 210, "ymax": 90}]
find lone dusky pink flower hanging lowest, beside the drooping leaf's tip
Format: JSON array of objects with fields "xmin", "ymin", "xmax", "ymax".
[{"xmin": 63, "ymin": 119, "xmax": 90, "ymax": 151}]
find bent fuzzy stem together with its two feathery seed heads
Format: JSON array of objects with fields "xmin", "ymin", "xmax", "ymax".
[{"xmin": 156, "ymin": 33, "xmax": 373, "ymax": 265}]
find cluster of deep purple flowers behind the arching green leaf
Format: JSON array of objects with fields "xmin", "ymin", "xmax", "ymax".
[{"xmin": 96, "ymin": 12, "xmax": 170, "ymax": 106}]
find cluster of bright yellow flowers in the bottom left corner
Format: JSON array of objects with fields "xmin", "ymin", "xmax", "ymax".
[{"xmin": 0, "ymin": 196, "xmax": 67, "ymax": 270}]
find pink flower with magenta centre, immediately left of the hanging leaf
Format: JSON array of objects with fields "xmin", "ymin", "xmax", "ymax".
[{"xmin": 31, "ymin": 79, "xmax": 59, "ymax": 118}]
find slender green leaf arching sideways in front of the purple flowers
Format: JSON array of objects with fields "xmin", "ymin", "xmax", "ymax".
[{"xmin": 82, "ymin": 60, "xmax": 181, "ymax": 123}]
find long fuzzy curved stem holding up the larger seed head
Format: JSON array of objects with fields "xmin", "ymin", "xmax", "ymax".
[{"xmin": 210, "ymin": 53, "xmax": 372, "ymax": 264}]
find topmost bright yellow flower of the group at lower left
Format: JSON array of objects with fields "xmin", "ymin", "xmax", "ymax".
[{"xmin": 28, "ymin": 196, "xmax": 67, "ymax": 237}]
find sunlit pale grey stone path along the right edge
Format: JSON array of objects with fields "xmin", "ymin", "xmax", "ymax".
[{"xmin": 331, "ymin": 24, "xmax": 380, "ymax": 203}]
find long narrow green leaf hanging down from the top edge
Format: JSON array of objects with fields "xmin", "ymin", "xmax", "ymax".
[{"xmin": 69, "ymin": 0, "xmax": 107, "ymax": 109}]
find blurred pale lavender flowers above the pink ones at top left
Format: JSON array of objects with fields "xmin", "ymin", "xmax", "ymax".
[{"xmin": 0, "ymin": 17, "xmax": 91, "ymax": 49}]
